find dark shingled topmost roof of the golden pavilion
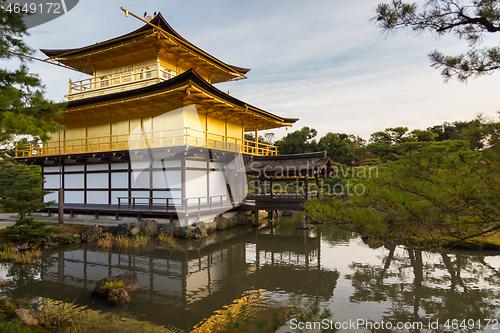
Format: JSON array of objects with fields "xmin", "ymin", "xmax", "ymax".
[{"xmin": 40, "ymin": 13, "xmax": 250, "ymax": 74}]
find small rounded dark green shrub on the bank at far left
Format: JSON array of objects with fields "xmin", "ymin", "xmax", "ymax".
[{"xmin": 7, "ymin": 217, "xmax": 55, "ymax": 246}]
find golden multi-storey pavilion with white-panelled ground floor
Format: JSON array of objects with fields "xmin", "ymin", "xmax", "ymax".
[{"xmin": 16, "ymin": 14, "xmax": 297, "ymax": 223}]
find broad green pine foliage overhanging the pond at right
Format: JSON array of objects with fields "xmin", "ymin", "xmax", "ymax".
[{"xmin": 306, "ymin": 141, "xmax": 500, "ymax": 245}]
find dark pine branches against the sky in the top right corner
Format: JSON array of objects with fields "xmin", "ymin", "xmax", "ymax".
[{"xmin": 372, "ymin": 0, "xmax": 500, "ymax": 82}]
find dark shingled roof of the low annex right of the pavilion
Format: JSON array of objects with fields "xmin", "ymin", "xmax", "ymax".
[{"xmin": 246, "ymin": 151, "xmax": 335, "ymax": 178}]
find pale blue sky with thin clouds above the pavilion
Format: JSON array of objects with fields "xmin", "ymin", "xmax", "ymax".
[{"xmin": 6, "ymin": 0, "xmax": 500, "ymax": 139}]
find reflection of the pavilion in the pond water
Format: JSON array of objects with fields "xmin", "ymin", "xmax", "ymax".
[{"xmin": 21, "ymin": 229, "xmax": 338, "ymax": 328}]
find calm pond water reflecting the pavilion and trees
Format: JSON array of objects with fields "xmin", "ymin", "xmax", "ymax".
[{"xmin": 0, "ymin": 216, "xmax": 500, "ymax": 333}]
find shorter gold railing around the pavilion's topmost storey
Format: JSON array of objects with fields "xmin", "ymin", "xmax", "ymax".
[{"xmin": 69, "ymin": 67, "xmax": 177, "ymax": 94}]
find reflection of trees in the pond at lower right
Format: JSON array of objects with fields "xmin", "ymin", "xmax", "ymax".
[{"xmin": 346, "ymin": 246, "xmax": 500, "ymax": 331}]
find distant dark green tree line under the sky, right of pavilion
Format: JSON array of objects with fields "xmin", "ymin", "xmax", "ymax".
[{"xmin": 274, "ymin": 115, "xmax": 500, "ymax": 165}]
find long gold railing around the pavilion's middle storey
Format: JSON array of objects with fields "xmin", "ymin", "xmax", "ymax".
[{"xmin": 16, "ymin": 127, "xmax": 278, "ymax": 158}]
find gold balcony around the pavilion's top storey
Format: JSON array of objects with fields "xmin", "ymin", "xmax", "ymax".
[{"xmin": 66, "ymin": 66, "xmax": 177, "ymax": 100}]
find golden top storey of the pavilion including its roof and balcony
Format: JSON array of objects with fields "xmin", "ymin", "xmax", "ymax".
[{"xmin": 41, "ymin": 14, "xmax": 249, "ymax": 100}]
